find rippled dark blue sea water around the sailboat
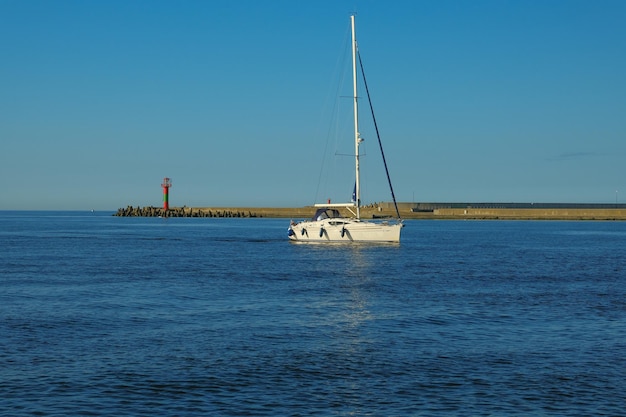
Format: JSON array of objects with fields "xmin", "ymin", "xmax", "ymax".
[{"xmin": 0, "ymin": 212, "xmax": 626, "ymax": 416}]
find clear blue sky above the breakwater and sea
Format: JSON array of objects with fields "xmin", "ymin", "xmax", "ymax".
[{"xmin": 0, "ymin": 0, "xmax": 626, "ymax": 210}]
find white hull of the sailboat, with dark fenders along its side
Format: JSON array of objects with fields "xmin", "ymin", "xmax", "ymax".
[{"xmin": 289, "ymin": 217, "xmax": 402, "ymax": 243}]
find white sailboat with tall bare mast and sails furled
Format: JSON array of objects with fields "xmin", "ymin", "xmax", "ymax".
[{"xmin": 288, "ymin": 15, "xmax": 404, "ymax": 243}]
